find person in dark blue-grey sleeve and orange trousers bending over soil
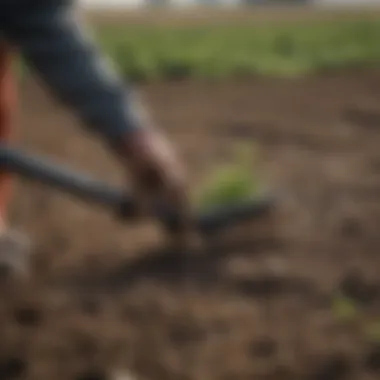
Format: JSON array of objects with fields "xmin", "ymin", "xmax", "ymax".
[{"xmin": 0, "ymin": 0, "xmax": 190, "ymax": 274}]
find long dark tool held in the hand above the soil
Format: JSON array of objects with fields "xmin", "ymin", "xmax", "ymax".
[{"xmin": 0, "ymin": 146, "xmax": 275, "ymax": 233}]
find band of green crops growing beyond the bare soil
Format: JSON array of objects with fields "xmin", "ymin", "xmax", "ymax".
[{"xmin": 96, "ymin": 19, "xmax": 380, "ymax": 81}]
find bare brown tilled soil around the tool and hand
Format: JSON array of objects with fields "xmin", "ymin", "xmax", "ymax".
[{"xmin": 0, "ymin": 71, "xmax": 380, "ymax": 380}]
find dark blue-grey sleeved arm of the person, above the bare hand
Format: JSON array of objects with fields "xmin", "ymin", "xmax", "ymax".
[{"xmin": 3, "ymin": 0, "xmax": 142, "ymax": 140}]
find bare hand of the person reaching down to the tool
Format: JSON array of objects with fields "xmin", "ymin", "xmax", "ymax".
[{"xmin": 115, "ymin": 128, "xmax": 191, "ymax": 245}]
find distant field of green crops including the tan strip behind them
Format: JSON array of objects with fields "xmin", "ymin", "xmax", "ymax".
[{"xmin": 84, "ymin": 7, "xmax": 380, "ymax": 82}]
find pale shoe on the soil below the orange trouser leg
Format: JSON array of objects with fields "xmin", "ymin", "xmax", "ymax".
[{"xmin": 0, "ymin": 230, "xmax": 31, "ymax": 279}]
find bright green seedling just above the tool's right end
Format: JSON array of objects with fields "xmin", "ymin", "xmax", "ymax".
[{"xmin": 197, "ymin": 146, "xmax": 260, "ymax": 208}]
